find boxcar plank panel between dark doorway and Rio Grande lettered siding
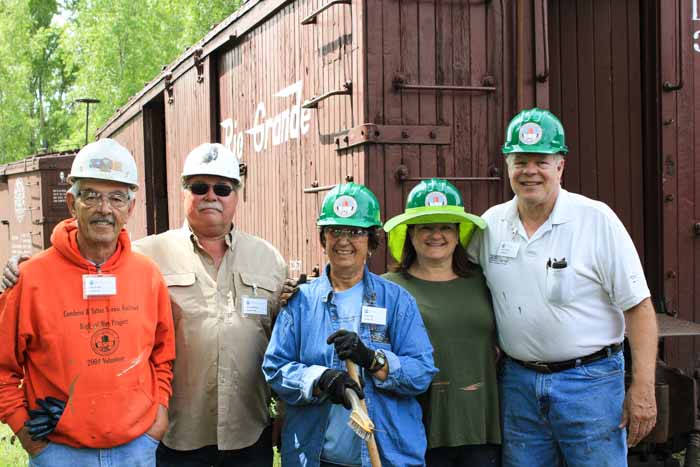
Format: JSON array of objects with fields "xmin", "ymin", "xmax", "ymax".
[{"xmin": 165, "ymin": 56, "xmax": 217, "ymax": 228}]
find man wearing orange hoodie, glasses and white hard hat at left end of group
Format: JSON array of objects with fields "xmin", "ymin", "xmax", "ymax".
[{"xmin": 0, "ymin": 139, "xmax": 175, "ymax": 467}]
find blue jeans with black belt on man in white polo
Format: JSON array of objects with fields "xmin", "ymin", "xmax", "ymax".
[{"xmin": 501, "ymin": 352, "xmax": 627, "ymax": 467}]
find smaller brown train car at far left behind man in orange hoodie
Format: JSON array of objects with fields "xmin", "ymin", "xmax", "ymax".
[{"xmin": 0, "ymin": 151, "xmax": 77, "ymax": 264}]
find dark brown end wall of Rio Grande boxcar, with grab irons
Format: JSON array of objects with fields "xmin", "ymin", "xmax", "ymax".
[{"xmin": 365, "ymin": 0, "xmax": 509, "ymax": 269}]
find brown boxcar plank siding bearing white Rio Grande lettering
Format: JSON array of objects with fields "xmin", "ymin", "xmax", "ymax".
[{"xmin": 218, "ymin": 0, "xmax": 363, "ymax": 274}]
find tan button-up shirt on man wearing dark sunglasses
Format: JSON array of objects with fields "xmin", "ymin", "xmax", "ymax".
[{"xmin": 134, "ymin": 226, "xmax": 287, "ymax": 450}]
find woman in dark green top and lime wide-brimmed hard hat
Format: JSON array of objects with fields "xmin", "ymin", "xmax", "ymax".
[{"xmin": 384, "ymin": 179, "xmax": 501, "ymax": 467}]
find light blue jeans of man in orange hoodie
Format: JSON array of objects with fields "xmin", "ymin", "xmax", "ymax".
[{"xmin": 29, "ymin": 434, "xmax": 158, "ymax": 467}]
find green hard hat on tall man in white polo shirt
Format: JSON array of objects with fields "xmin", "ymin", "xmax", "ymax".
[{"xmin": 501, "ymin": 107, "xmax": 569, "ymax": 154}]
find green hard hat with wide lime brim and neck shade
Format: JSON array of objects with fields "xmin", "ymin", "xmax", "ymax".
[{"xmin": 384, "ymin": 178, "xmax": 486, "ymax": 262}]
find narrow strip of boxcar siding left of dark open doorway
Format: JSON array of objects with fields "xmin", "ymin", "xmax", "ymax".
[{"xmin": 110, "ymin": 113, "xmax": 148, "ymax": 240}]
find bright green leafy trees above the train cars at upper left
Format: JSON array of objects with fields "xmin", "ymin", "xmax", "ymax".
[{"xmin": 0, "ymin": 0, "xmax": 241, "ymax": 163}]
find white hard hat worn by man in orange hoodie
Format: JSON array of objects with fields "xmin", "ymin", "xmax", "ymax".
[{"xmin": 67, "ymin": 138, "xmax": 139, "ymax": 191}]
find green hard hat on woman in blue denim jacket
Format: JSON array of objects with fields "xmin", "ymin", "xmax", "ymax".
[{"xmin": 316, "ymin": 182, "xmax": 382, "ymax": 228}]
